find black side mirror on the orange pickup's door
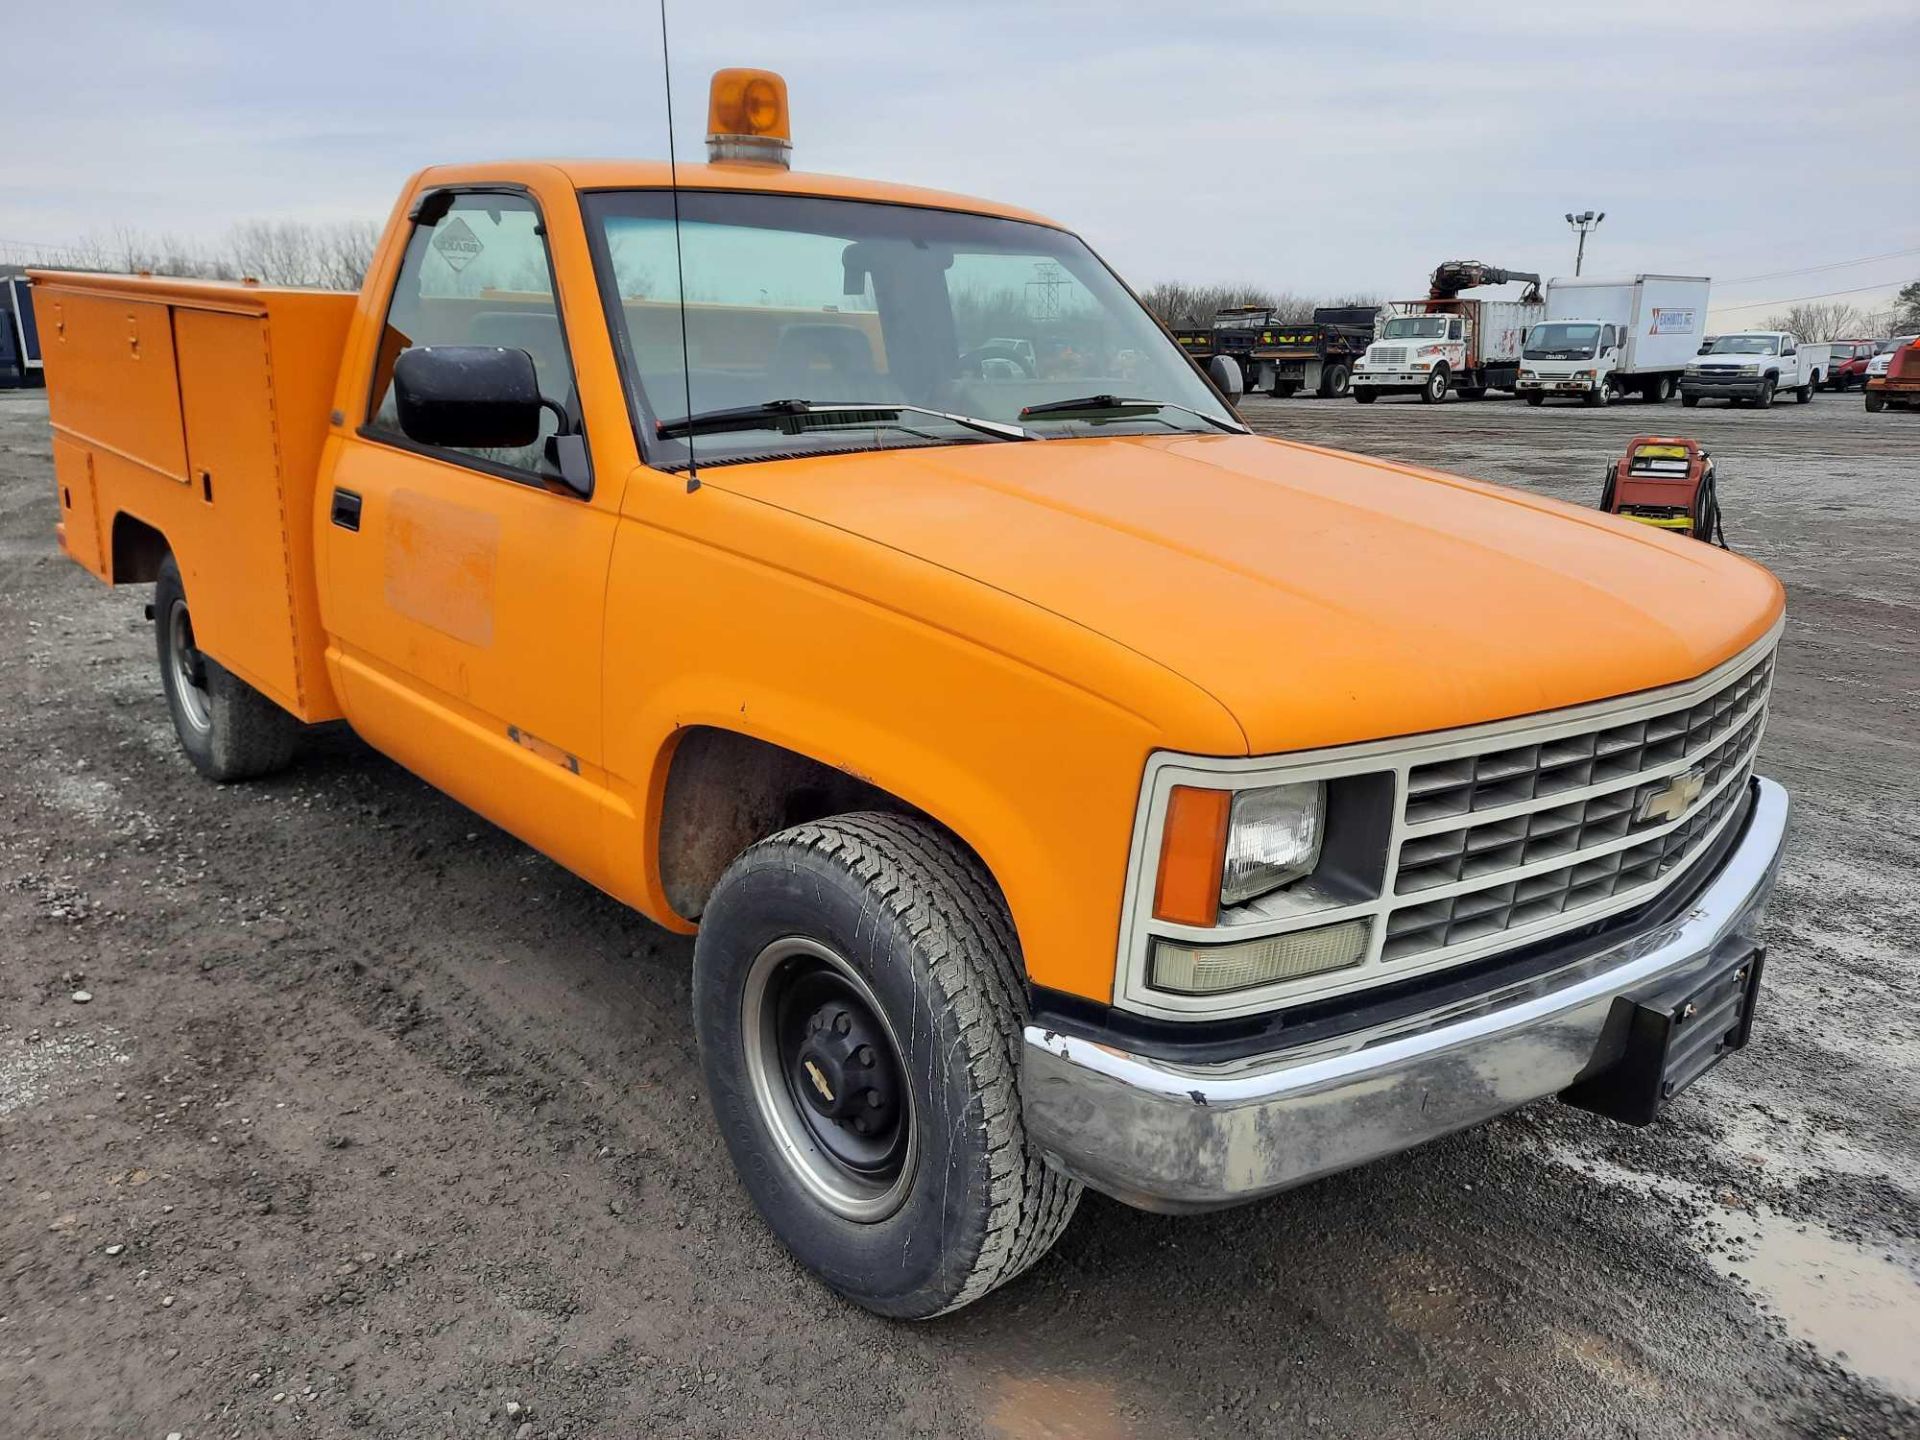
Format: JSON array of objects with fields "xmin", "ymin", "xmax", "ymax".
[{"xmin": 394, "ymin": 346, "xmax": 541, "ymax": 449}]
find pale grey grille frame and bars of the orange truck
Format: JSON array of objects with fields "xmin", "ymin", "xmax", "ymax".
[{"xmin": 1114, "ymin": 622, "xmax": 1784, "ymax": 1020}]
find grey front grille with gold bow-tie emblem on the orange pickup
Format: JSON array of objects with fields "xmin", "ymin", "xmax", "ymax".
[{"xmin": 1380, "ymin": 655, "xmax": 1772, "ymax": 964}]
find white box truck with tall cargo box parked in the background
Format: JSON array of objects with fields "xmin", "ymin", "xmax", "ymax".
[{"xmin": 1519, "ymin": 275, "xmax": 1707, "ymax": 405}]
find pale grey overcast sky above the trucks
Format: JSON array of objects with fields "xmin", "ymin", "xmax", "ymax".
[{"xmin": 0, "ymin": 0, "xmax": 1920, "ymax": 326}]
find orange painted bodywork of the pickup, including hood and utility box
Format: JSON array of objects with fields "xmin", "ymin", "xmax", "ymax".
[{"xmin": 35, "ymin": 161, "xmax": 1782, "ymax": 1000}]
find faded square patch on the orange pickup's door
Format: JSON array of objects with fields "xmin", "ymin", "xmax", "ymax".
[{"xmin": 386, "ymin": 490, "xmax": 499, "ymax": 645}]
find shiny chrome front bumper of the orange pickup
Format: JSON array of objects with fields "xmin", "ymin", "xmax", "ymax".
[{"xmin": 1021, "ymin": 778, "xmax": 1788, "ymax": 1212}]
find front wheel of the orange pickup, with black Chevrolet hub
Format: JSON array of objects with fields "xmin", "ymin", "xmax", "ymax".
[{"xmin": 693, "ymin": 812, "xmax": 1081, "ymax": 1319}]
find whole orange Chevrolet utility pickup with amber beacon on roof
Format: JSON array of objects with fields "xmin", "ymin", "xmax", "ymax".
[{"xmin": 35, "ymin": 73, "xmax": 1788, "ymax": 1317}]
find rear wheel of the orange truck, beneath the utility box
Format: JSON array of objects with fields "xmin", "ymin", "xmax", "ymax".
[{"xmin": 154, "ymin": 555, "xmax": 300, "ymax": 783}]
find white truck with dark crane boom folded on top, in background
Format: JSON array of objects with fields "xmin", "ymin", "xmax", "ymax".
[{"xmin": 1354, "ymin": 259, "xmax": 1544, "ymax": 405}]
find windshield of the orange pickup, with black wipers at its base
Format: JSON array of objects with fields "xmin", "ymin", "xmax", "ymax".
[{"xmin": 582, "ymin": 190, "xmax": 1235, "ymax": 465}]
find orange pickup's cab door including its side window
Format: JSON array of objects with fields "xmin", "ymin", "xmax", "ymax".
[{"xmin": 323, "ymin": 190, "xmax": 616, "ymax": 877}]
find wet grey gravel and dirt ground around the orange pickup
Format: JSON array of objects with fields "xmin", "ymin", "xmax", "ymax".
[{"xmin": 0, "ymin": 385, "xmax": 1920, "ymax": 1440}]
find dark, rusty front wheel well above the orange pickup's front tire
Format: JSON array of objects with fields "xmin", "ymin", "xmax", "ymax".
[{"xmin": 659, "ymin": 726, "xmax": 956, "ymax": 920}]
